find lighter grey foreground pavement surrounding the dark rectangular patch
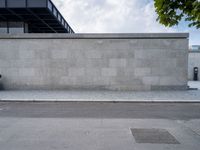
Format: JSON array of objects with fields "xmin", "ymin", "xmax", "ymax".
[{"xmin": 0, "ymin": 118, "xmax": 200, "ymax": 150}]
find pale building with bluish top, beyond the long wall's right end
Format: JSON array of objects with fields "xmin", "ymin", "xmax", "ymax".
[{"xmin": 188, "ymin": 45, "xmax": 200, "ymax": 80}]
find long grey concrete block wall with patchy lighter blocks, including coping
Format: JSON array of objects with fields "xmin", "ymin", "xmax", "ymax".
[{"xmin": 0, "ymin": 33, "xmax": 188, "ymax": 90}]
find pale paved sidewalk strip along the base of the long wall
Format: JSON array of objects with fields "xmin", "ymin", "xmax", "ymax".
[{"xmin": 0, "ymin": 82, "xmax": 200, "ymax": 102}]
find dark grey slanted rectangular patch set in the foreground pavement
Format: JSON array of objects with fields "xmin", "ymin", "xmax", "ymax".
[{"xmin": 131, "ymin": 129, "xmax": 180, "ymax": 144}]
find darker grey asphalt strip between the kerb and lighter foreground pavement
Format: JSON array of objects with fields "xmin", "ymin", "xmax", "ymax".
[{"xmin": 0, "ymin": 102, "xmax": 200, "ymax": 120}]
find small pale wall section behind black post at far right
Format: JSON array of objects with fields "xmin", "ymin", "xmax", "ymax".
[{"xmin": 188, "ymin": 51, "xmax": 200, "ymax": 80}]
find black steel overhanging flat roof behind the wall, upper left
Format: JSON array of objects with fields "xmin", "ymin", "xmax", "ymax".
[{"xmin": 0, "ymin": 0, "xmax": 74, "ymax": 33}]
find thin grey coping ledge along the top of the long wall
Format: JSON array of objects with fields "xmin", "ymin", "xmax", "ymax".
[{"xmin": 0, "ymin": 33, "xmax": 189, "ymax": 39}]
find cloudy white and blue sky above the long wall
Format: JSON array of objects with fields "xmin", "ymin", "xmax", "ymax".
[{"xmin": 52, "ymin": 0, "xmax": 200, "ymax": 45}]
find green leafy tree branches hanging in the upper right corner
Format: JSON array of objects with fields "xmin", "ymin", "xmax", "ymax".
[{"xmin": 154, "ymin": 0, "xmax": 200, "ymax": 29}]
